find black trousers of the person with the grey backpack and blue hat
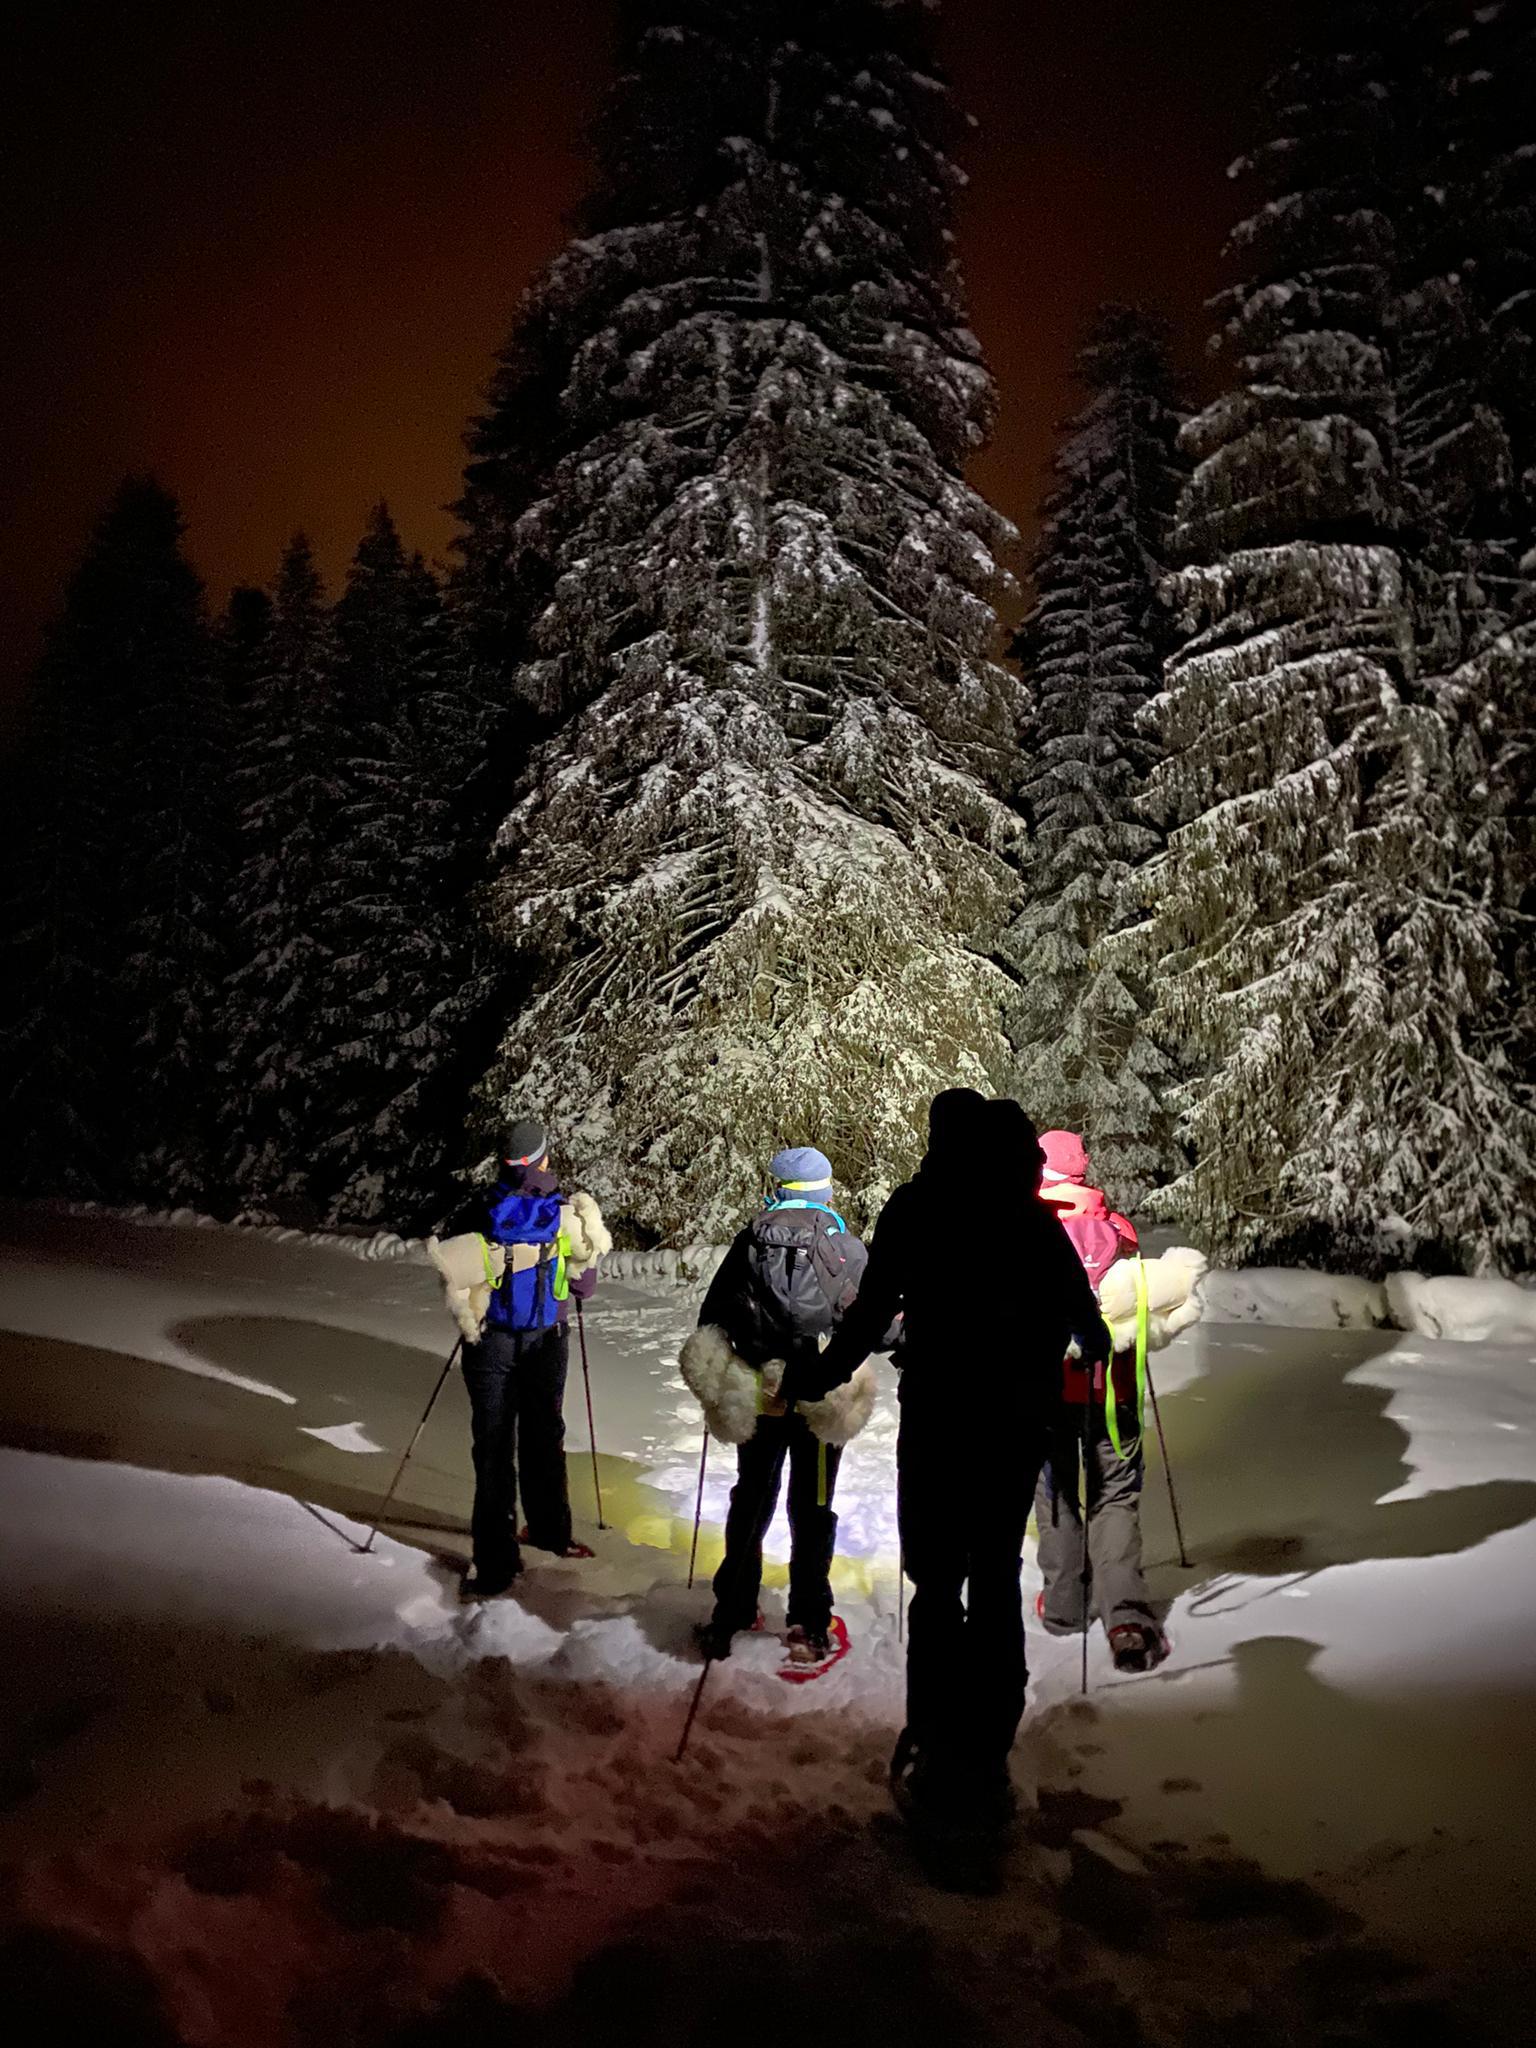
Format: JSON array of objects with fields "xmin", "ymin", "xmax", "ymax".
[{"xmin": 715, "ymin": 1413, "xmax": 842, "ymax": 1636}]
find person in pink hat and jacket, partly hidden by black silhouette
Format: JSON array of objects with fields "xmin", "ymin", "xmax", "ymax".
[{"xmin": 1034, "ymin": 1130, "xmax": 1167, "ymax": 1671}]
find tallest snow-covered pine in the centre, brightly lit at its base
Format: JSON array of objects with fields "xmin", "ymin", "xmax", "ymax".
[{"xmin": 461, "ymin": 0, "xmax": 1020, "ymax": 1241}]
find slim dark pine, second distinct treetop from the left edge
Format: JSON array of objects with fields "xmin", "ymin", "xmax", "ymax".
[{"xmin": 223, "ymin": 535, "xmax": 344, "ymax": 1223}]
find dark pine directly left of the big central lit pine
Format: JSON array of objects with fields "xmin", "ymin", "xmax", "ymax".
[{"xmin": 311, "ymin": 504, "xmax": 479, "ymax": 1229}]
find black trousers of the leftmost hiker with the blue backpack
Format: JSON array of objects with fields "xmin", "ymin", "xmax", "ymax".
[{"xmin": 465, "ymin": 1323, "xmax": 571, "ymax": 1579}]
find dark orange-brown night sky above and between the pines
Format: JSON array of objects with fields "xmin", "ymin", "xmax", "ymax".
[{"xmin": 0, "ymin": 0, "xmax": 1296, "ymax": 720}]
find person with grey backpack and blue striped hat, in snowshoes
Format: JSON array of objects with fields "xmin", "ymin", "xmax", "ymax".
[{"xmin": 682, "ymin": 1145, "xmax": 872, "ymax": 1677}]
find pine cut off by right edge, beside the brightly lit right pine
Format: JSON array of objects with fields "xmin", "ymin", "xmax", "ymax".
[{"xmin": 1397, "ymin": 0, "xmax": 1536, "ymax": 1236}]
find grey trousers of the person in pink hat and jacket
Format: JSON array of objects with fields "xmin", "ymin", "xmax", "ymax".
[{"xmin": 1034, "ymin": 1411, "xmax": 1157, "ymax": 1628}]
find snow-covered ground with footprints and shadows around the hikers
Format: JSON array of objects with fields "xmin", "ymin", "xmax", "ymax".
[{"xmin": 0, "ymin": 1210, "xmax": 1536, "ymax": 2048}]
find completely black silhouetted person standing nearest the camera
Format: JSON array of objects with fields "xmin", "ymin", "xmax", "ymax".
[{"xmin": 786, "ymin": 1087, "xmax": 1108, "ymax": 1833}]
